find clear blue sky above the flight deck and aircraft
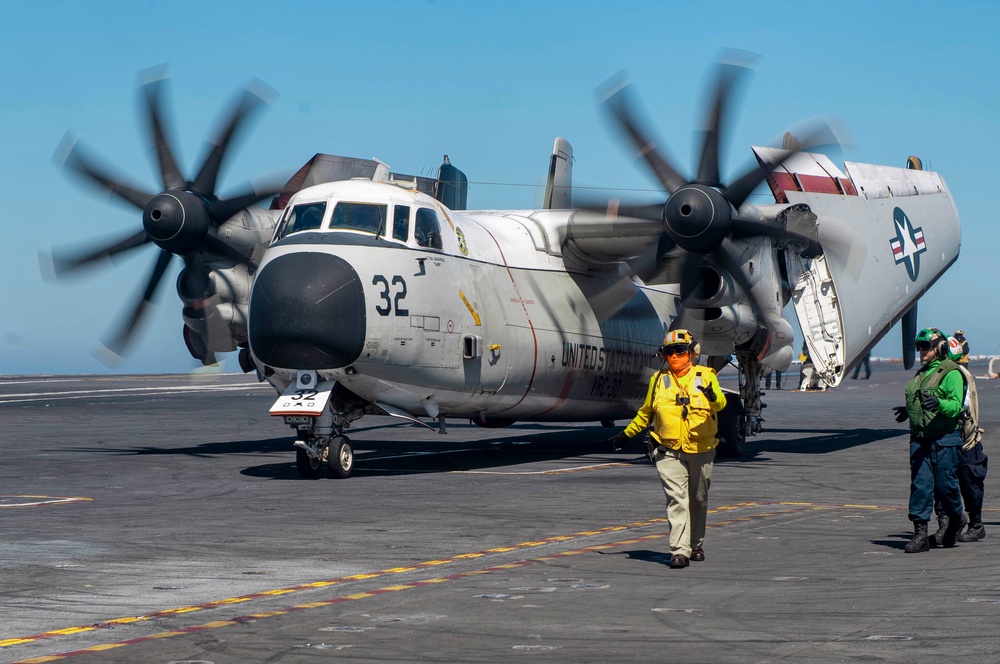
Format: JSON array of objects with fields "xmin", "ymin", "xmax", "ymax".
[{"xmin": 0, "ymin": 0, "xmax": 1000, "ymax": 374}]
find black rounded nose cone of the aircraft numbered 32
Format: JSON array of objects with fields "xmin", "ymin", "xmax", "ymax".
[{"xmin": 248, "ymin": 252, "xmax": 365, "ymax": 369}]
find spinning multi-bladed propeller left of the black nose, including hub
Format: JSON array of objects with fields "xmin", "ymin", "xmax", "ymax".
[{"xmin": 48, "ymin": 68, "xmax": 280, "ymax": 364}]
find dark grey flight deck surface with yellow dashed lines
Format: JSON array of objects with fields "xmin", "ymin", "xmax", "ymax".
[{"xmin": 0, "ymin": 364, "xmax": 1000, "ymax": 664}]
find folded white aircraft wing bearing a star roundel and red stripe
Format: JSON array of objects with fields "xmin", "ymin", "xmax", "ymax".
[{"xmin": 754, "ymin": 147, "xmax": 961, "ymax": 386}]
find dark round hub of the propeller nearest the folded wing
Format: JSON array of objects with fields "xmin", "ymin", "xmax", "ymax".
[{"xmin": 663, "ymin": 184, "xmax": 733, "ymax": 254}]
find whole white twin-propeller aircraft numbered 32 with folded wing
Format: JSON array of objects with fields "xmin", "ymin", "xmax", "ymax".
[{"xmin": 51, "ymin": 65, "xmax": 960, "ymax": 478}]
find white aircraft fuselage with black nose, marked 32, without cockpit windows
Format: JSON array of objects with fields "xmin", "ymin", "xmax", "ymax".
[{"xmin": 249, "ymin": 181, "xmax": 677, "ymax": 421}]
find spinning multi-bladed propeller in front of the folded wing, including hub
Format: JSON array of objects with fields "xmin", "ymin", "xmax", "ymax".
[{"xmin": 586, "ymin": 55, "xmax": 836, "ymax": 340}]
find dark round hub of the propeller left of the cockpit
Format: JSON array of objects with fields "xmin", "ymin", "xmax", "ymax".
[{"xmin": 142, "ymin": 191, "xmax": 210, "ymax": 256}]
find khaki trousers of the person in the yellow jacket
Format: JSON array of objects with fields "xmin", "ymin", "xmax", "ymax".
[{"xmin": 656, "ymin": 449, "xmax": 715, "ymax": 558}]
